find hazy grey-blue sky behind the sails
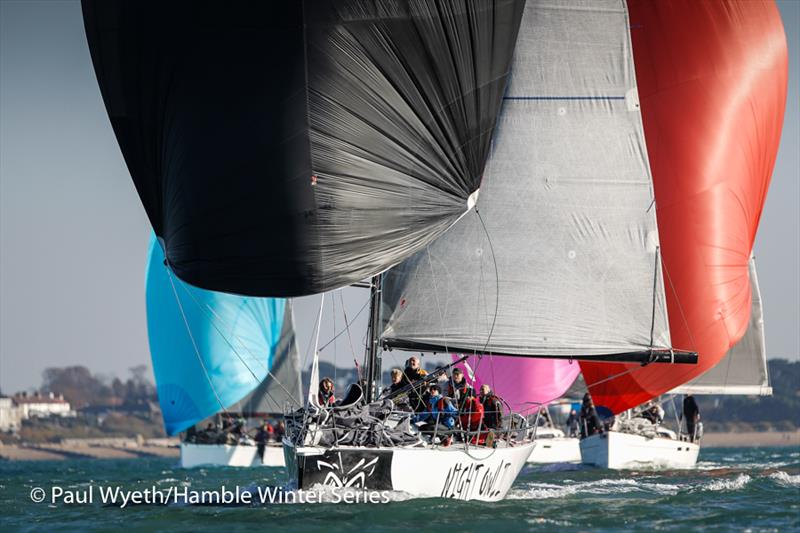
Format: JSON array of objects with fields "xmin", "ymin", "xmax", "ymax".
[{"xmin": 0, "ymin": 0, "xmax": 800, "ymax": 393}]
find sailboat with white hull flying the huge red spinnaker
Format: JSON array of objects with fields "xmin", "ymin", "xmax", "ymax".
[{"xmin": 581, "ymin": 0, "xmax": 787, "ymax": 468}]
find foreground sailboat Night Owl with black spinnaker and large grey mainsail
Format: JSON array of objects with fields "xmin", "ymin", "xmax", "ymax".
[{"xmin": 83, "ymin": 0, "xmax": 712, "ymax": 501}]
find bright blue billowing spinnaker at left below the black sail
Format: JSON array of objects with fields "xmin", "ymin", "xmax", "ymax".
[{"xmin": 145, "ymin": 239, "xmax": 301, "ymax": 435}]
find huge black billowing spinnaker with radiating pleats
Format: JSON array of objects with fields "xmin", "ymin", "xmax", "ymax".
[{"xmin": 83, "ymin": 0, "xmax": 524, "ymax": 296}]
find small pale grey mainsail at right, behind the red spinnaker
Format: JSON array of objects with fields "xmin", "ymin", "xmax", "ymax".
[{"xmin": 672, "ymin": 257, "xmax": 772, "ymax": 396}]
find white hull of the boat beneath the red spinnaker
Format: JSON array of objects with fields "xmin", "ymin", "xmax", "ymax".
[{"xmin": 580, "ymin": 431, "xmax": 700, "ymax": 470}]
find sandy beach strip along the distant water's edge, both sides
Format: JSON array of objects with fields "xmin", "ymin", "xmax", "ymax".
[{"xmin": 0, "ymin": 430, "xmax": 800, "ymax": 461}]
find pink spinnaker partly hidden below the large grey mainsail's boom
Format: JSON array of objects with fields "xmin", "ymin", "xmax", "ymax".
[{"xmin": 452, "ymin": 354, "xmax": 581, "ymax": 414}]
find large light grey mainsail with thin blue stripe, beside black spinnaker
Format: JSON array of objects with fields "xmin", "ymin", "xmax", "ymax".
[{"xmin": 383, "ymin": 0, "xmax": 671, "ymax": 358}]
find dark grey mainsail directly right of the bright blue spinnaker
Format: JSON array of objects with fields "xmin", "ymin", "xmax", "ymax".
[{"xmin": 235, "ymin": 300, "xmax": 303, "ymax": 416}]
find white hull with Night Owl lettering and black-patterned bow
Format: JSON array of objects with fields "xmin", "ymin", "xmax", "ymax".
[{"xmin": 284, "ymin": 440, "xmax": 533, "ymax": 501}]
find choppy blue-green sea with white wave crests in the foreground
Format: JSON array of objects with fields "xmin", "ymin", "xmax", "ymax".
[{"xmin": 0, "ymin": 447, "xmax": 800, "ymax": 533}]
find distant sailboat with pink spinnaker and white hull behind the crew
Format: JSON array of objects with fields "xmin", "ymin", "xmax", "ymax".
[{"xmin": 453, "ymin": 355, "xmax": 581, "ymax": 464}]
